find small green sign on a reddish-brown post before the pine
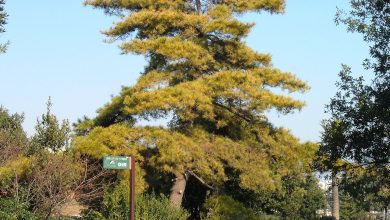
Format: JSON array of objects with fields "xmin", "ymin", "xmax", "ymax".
[{"xmin": 103, "ymin": 156, "xmax": 135, "ymax": 220}]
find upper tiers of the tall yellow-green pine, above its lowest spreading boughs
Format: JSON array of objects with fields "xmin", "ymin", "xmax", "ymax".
[{"xmin": 86, "ymin": 0, "xmax": 308, "ymax": 127}]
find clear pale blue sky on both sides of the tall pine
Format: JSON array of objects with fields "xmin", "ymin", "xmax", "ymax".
[{"xmin": 0, "ymin": 0, "xmax": 368, "ymax": 141}]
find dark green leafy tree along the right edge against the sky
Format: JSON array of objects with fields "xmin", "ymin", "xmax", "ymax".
[{"xmin": 329, "ymin": 0, "xmax": 390, "ymax": 165}]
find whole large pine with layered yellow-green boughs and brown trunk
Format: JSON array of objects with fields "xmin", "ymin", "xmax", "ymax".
[{"xmin": 75, "ymin": 0, "xmax": 316, "ymax": 211}]
